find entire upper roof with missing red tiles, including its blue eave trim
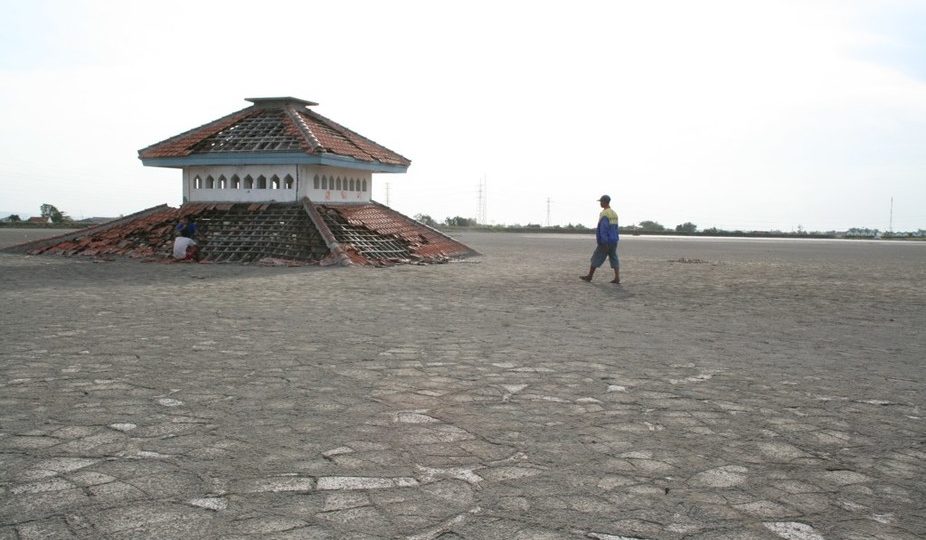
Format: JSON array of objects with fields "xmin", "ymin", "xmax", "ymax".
[{"xmin": 138, "ymin": 97, "xmax": 411, "ymax": 172}]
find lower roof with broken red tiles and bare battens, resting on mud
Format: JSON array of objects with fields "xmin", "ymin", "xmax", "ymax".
[{"xmin": 3, "ymin": 199, "xmax": 477, "ymax": 266}]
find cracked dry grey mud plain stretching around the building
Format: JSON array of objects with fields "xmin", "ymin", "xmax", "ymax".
[{"xmin": 0, "ymin": 231, "xmax": 926, "ymax": 540}]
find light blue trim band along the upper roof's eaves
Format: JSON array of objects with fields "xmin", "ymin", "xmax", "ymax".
[{"xmin": 141, "ymin": 152, "xmax": 408, "ymax": 173}]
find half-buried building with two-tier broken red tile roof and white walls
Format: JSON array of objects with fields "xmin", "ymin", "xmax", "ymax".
[{"xmin": 7, "ymin": 97, "xmax": 475, "ymax": 265}]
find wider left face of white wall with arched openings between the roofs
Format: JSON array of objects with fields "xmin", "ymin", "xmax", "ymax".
[{"xmin": 183, "ymin": 165, "xmax": 300, "ymax": 202}]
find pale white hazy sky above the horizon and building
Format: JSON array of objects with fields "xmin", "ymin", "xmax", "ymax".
[{"xmin": 0, "ymin": 0, "xmax": 926, "ymax": 230}]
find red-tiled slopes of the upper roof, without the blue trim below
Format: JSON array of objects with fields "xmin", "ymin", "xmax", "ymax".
[{"xmin": 138, "ymin": 98, "xmax": 411, "ymax": 167}]
